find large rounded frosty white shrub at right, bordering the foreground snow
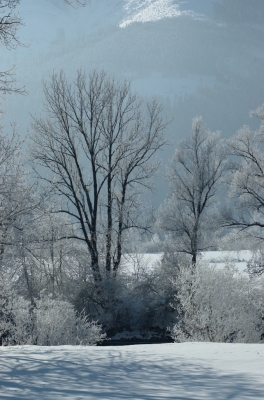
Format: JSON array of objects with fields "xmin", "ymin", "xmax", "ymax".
[{"xmin": 173, "ymin": 263, "xmax": 263, "ymax": 343}]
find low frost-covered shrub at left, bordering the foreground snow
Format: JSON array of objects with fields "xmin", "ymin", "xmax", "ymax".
[{"xmin": 3, "ymin": 296, "xmax": 105, "ymax": 346}]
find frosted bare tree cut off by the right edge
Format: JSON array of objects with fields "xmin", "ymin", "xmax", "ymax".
[{"xmin": 223, "ymin": 104, "xmax": 264, "ymax": 240}]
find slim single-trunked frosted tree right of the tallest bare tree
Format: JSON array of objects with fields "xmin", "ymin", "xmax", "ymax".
[{"xmin": 158, "ymin": 117, "xmax": 226, "ymax": 264}]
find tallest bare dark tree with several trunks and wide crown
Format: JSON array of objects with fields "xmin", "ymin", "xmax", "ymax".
[{"xmin": 29, "ymin": 72, "xmax": 165, "ymax": 282}]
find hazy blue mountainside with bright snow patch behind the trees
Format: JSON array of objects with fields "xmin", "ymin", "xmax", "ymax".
[{"xmin": 0, "ymin": 0, "xmax": 264, "ymax": 203}]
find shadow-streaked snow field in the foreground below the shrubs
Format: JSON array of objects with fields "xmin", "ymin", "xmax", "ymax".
[{"xmin": 0, "ymin": 343, "xmax": 264, "ymax": 400}]
